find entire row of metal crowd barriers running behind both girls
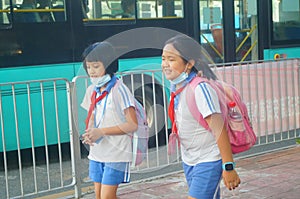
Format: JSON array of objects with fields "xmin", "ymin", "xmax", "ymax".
[{"xmin": 0, "ymin": 59, "xmax": 300, "ymax": 198}]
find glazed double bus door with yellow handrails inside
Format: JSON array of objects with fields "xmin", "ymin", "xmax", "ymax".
[{"xmin": 199, "ymin": 0, "xmax": 258, "ymax": 63}]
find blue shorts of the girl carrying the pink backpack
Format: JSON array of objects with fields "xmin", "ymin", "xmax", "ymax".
[{"xmin": 183, "ymin": 160, "xmax": 222, "ymax": 199}]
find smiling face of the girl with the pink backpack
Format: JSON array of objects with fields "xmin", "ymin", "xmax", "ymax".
[{"xmin": 161, "ymin": 44, "xmax": 187, "ymax": 80}]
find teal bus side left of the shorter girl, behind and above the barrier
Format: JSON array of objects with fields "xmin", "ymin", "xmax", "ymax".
[{"xmin": 0, "ymin": 64, "xmax": 77, "ymax": 152}]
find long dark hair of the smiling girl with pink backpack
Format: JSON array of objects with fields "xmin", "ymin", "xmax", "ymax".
[{"xmin": 165, "ymin": 34, "xmax": 217, "ymax": 80}]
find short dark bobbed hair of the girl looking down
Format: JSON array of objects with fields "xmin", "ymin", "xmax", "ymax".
[{"xmin": 82, "ymin": 41, "xmax": 119, "ymax": 76}]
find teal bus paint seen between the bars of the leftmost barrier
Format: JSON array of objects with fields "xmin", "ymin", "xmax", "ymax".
[{"xmin": 0, "ymin": 80, "xmax": 70, "ymax": 151}]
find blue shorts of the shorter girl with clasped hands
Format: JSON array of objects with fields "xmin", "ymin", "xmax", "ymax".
[{"xmin": 89, "ymin": 160, "xmax": 130, "ymax": 185}]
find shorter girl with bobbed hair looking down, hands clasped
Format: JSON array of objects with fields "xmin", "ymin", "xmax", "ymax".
[{"xmin": 81, "ymin": 42, "xmax": 137, "ymax": 199}]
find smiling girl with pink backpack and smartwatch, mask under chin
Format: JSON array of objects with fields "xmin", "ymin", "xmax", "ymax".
[{"xmin": 161, "ymin": 34, "xmax": 251, "ymax": 199}]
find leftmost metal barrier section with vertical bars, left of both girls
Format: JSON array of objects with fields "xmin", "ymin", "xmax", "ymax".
[{"xmin": 0, "ymin": 79, "xmax": 75, "ymax": 198}]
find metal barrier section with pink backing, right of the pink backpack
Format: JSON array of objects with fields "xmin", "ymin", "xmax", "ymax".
[{"xmin": 214, "ymin": 59, "xmax": 300, "ymax": 146}]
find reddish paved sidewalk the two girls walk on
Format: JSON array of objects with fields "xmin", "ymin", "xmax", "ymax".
[{"xmin": 82, "ymin": 146, "xmax": 300, "ymax": 199}]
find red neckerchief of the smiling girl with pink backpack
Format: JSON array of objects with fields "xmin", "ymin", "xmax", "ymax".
[{"xmin": 168, "ymin": 86, "xmax": 185, "ymax": 154}]
